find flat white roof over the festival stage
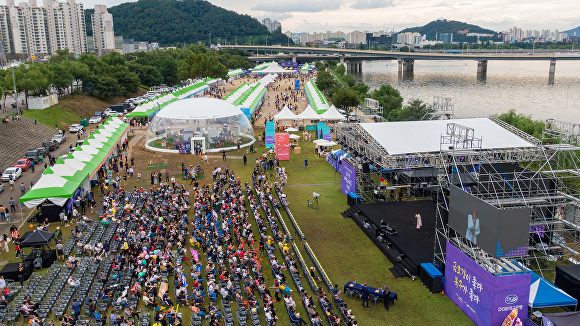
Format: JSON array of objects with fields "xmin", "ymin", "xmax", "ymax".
[{"xmin": 360, "ymin": 118, "xmax": 535, "ymax": 155}]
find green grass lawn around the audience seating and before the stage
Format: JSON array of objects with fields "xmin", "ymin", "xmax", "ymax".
[{"xmin": 0, "ymin": 130, "xmax": 473, "ymax": 325}]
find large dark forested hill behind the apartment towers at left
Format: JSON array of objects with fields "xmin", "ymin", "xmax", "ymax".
[{"xmin": 85, "ymin": 0, "xmax": 288, "ymax": 46}]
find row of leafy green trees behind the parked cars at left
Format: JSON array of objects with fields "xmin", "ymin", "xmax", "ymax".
[{"xmin": 0, "ymin": 45, "xmax": 252, "ymax": 101}]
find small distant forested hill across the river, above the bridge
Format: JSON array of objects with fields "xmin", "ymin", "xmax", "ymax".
[{"xmin": 399, "ymin": 19, "xmax": 497, "ymax": 42}]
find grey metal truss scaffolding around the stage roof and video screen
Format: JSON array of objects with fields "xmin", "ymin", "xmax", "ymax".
[{"xmin": 334, "ymin": 119, "xmax": 580, "ymax": 276}]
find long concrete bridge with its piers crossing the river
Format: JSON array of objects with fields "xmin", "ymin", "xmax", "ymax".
[{"xmin": 219, "ymin": 45, "xmax": 580, "ymax": 85}]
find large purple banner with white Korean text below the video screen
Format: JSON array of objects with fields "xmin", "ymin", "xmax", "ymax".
[{"xmin": 445, "ymin": 242, "xmax": 532, "ymax": 326}]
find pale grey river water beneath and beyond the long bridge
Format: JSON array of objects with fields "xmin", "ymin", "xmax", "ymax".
[{"xmin": 354, "ymin": 60, "xmax": 580, "ymax": 123}]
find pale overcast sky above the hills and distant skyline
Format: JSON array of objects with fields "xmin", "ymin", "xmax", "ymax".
[{"xmin": 79, "ymin": 0, "xmax": 580, "ymax": 32}]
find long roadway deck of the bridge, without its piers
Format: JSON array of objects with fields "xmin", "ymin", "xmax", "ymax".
[{"xmin": 219, "ymin": 45, "xmax": 580, "ymax": 61}]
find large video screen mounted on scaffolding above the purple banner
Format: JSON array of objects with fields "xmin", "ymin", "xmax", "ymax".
[{"xmin": 449, "ymin": 185, "xmax": 530, "ymax": 257}]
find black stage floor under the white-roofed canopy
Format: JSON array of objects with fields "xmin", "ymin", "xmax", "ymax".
[{"xmin": 342, "ymin": 200, "xmax": 435, "ymax": 278}]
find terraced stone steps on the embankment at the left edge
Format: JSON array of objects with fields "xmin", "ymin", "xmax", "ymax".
[{"xmin": 0, "ymin": 117, "xmax": 56, "ymax": 173}]
